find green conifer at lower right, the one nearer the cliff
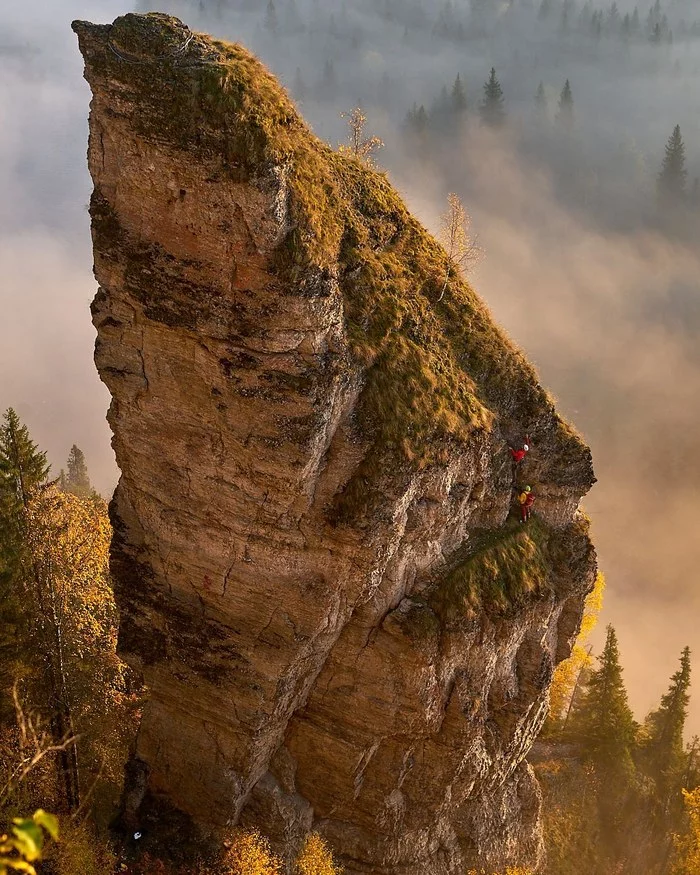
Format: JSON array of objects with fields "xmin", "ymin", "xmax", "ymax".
[{"xmin": 572, "ymin": 626, "xmax": 636, "ymax": 775}]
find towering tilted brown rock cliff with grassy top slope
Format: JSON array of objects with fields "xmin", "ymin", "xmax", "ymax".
[{"xmin": 73, "ymin": 15, "xmax": 595, "ymax": 875}]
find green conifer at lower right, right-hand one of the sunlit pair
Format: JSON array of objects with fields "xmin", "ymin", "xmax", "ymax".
[{"xmin": 644, "ymin": 647, "xmax": 690, "ymax": 795}]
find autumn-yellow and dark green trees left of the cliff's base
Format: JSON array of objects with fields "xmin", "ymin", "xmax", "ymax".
[{"xmin": 0, "ymin": 409, "xmax": 138, "ymax": 875}]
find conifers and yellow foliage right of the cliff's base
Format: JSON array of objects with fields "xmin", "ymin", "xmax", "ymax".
[{"xmin": 535, "ymin": 628, "xmax": 700, "ymax": 875}]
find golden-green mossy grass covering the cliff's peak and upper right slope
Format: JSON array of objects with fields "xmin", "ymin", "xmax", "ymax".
[{"xmin": 73, "ymin": 13, "xmax": 593, "ymax": 519}]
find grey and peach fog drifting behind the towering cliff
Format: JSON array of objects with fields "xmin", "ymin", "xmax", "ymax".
[{"xmin": 0, "ymin": 0, "xmax": 700, "ymax": 731}]
